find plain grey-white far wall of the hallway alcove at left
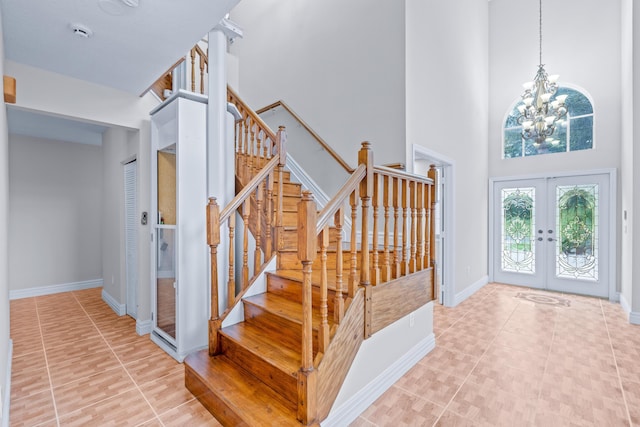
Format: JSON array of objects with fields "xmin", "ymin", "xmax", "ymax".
[{"xmin": 9, "ymin": 135, "xmax": 102, "ymax": 290}]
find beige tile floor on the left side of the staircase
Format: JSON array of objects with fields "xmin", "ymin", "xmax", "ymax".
[{"xmin": 10, "ymin": 288, "xmax": 220, "ymax": 427}]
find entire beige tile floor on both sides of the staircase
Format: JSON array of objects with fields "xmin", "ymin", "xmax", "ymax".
[{"xmin": 11, "ymin": 284, "xmax": 640, "ymax": 427}]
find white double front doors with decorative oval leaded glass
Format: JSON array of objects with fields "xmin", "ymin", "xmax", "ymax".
[{"xmin": 493, "ymin": 174, "xmax": 615, "ymax": 297}]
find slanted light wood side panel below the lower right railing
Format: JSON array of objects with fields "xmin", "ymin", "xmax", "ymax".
[{"xmin": 318, "ymin": 289, "xmax": 364, "ymax": 420}]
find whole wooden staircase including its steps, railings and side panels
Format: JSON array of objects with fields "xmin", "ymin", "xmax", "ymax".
[{"xmin": 184, "ymin": 86, "xmax": 435, "ymax": 426}]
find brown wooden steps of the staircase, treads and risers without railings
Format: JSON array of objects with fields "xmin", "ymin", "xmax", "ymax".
[{"xmin": 185, "ymin": 165, "xmax": 335, "ymax": 426}]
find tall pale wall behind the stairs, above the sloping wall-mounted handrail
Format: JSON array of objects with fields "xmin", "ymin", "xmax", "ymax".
[{"xmin": 231, "ymin": 0, "xmax": 405, "ymax": 166}]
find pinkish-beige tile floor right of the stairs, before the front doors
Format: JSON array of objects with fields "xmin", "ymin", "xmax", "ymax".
[{"xmin": 352, "ymin": 284, "xmax": 640, "ymax": 427}]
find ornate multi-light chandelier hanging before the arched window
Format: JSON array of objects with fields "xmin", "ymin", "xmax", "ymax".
[{"xmin": 518, "ymin": 0, "xmax": 567, "ymax": 152}]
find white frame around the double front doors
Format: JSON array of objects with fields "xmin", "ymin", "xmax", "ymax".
[{"xmin": 487, "ymin": 168, "xmax": 618, "ymax": 301}]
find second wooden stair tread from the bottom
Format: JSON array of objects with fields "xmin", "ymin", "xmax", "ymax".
[{"xmin": 220, "ymin": 322, "xmax": 301, "ymax": 378}]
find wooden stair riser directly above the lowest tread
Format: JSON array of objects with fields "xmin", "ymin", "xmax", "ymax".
[{"xmin": 220, "ymin": 333, "xmax": 298, "ymax": 402}]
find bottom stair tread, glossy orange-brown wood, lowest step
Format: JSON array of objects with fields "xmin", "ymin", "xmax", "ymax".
[{"xmin": 184, "ymin": 350, "xmax": 301, "ymax": 426}]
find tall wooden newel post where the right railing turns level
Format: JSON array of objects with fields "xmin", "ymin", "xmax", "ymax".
[{"xmin": 352, "ymin": 141, "xmax": 373, "ymax": 339}]
